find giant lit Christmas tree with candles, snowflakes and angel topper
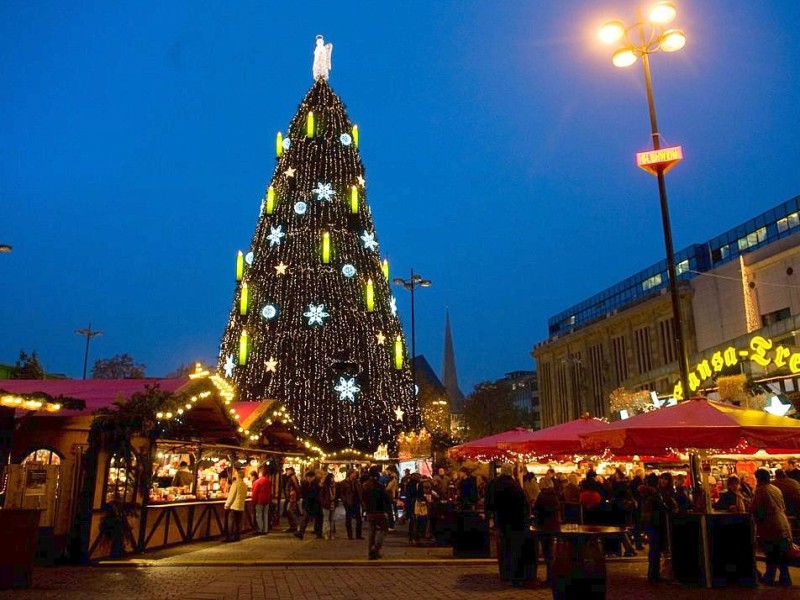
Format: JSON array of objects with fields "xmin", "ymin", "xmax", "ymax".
[{"xmin": 219, "ymin": 38, "xmax": 419, "ymax": 452}]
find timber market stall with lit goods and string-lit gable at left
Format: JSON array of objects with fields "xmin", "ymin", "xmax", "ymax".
[{"xmin": 3, "ymin": 370, "xmax": 277, "ymax": 560}]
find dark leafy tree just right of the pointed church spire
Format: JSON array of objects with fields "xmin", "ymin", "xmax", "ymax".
[{"xmin": 464, "ymin": 381, "xmax": 527, "ymax": 440}]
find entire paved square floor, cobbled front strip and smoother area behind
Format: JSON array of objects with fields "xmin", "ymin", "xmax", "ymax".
[{"xmin": 0, "ymin": 516, "xmax": 800, "ymax": 600}]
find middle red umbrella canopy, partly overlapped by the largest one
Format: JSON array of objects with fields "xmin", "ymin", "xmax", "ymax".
[{"xmin": 497, "ymin": 415, "xmax": 609, "ymax": 457}]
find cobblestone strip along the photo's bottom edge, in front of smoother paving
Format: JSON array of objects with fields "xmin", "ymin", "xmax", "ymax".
[{"xmin": 0, "ymin": 561, "xmax": 800, "ymax": 600}]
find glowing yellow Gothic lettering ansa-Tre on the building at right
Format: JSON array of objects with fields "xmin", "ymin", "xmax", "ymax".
[{"xmin": 672, "ymin": 335, "xmax": 800, "ymax": 400}]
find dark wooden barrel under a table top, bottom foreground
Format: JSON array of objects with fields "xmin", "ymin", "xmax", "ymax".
[{"xmin": 551, "ymin": 536, "xmax": 606, "ymax": 600}]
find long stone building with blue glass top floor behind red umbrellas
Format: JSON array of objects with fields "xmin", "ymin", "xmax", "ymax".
[{"xmin": 531, "ymin": 196, "xmax": 800, "ymax": 427}]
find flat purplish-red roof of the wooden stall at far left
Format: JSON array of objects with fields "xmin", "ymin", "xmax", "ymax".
[{"xmin": 0, "ymin": 377, "xmax": 191, "ymax": 417}]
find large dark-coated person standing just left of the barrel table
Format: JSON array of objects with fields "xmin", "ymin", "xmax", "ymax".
[{"xmin": 486, "ymin": 464, "xmax": 529, "ymax": 587}]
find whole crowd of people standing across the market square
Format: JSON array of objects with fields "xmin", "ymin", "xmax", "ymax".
[{"xmin": 226, "ymin": 460, "xmax": 800, "ymax": 586}]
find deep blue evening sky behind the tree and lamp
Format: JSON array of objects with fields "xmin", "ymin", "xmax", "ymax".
[{"xmin": 0, "ymin": 0, "xmax": 800, "ymax": 393}]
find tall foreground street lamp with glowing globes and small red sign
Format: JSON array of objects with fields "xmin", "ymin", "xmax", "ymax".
[{"xmin": 599, "ymin": 2, "xmax": 689, "ymax": 398}]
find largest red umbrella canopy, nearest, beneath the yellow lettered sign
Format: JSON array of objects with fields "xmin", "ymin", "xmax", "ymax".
[{"xmin": 580, "ymin": 398, "xmax": 800, "ymax": 454}]
